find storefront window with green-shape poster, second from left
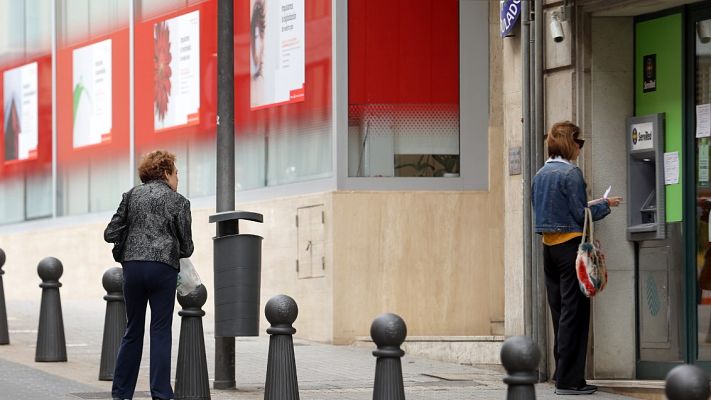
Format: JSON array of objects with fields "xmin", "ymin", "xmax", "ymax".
[{"xmin": 56, "ymin": 0, "xmax": 130, "ymax": 215}]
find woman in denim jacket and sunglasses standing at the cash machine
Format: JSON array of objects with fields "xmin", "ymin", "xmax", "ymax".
[{"xmin": 531, "ymin": 121, "xmax": 621, "ymax": 395}]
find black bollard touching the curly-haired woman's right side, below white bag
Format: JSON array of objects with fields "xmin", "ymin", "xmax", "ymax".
[{"xmin": 175, "ymin": 285, "xmax": 210, "ymax": 400}]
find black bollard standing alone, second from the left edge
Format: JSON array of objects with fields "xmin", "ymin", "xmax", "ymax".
[{"xmin": 35, "ymin": 257, "xmax": 67, "ymax": 362}]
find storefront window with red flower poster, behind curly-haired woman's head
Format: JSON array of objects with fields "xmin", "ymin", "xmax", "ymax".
[{"xmin": 134, "ymin": 0, "xmax": 217, "ymax": 197}]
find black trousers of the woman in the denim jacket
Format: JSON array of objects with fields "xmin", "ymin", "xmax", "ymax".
[{"xmin": 543, "ymin": 237, "xmax": 590, "ymax": 388}]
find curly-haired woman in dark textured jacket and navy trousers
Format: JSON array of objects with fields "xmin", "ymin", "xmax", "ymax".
[{"xmin": 104, "ymin": 150, "xmax": 193, "ymax": 399}]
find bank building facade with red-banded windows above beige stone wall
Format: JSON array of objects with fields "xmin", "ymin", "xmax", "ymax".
[{"xmin": 0, "ymin": 0, "xmax": 506, "ymax": 362}]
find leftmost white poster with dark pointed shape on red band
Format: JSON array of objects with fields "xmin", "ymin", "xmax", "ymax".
[{"xmin": 3, "ymin": 62, "xmax": 38, "ymax": 161}]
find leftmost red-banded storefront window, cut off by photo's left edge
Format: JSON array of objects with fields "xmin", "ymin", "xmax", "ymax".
[{"xmin": 0, "ymin": 0, "xmax": 52, "ymax": 224}]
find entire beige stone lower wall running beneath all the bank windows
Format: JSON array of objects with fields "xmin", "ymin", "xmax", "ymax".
[{"xmin": 0, "ymin": 185, "xmax": 504, "ymax": 343}]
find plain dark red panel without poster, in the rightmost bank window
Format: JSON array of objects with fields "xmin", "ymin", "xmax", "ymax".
[{"xmin": 348, "ymin": 0, "xmax": 459, "ymax": 104}]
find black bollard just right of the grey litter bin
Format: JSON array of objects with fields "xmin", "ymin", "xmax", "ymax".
[{"xmin": 264, "ymin": 294, "xmax": 299, "ymax": 400}]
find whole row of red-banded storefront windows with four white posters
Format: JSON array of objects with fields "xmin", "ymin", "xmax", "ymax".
[{"xmin": 0, "ymin": 0, "xmax": 333, "ymax": 224}]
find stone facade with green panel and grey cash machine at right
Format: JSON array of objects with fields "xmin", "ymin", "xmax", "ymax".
[{"xmin": 502, "ymin": 0, "xmax": 711, "ymax": 380}]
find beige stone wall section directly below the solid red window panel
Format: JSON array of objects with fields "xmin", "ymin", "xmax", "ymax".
[{"xmin": 333, "ymin": 192, "xmax": 503, "ymax": 343}]
